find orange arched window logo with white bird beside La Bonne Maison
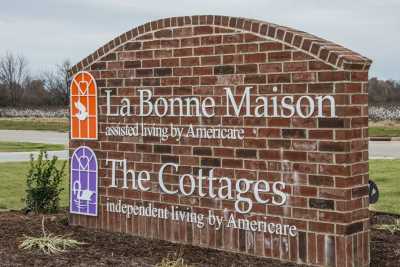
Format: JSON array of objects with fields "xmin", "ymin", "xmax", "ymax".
[{"xmin": 70, "ymin": 71, "xmax": 97, "ymax": 139}]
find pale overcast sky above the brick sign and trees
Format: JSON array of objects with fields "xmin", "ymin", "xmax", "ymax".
[{"xmin": 0, "ymin": 0, "xmax": 400, "ymax": 80}]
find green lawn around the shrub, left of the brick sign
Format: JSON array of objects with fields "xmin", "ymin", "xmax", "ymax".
[{"xmin": 0, "ymin": 162, "xmax": 69, "ymax": 209}]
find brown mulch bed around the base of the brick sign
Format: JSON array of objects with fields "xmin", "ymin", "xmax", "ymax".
[{"xmin": 0, "ymin": 212, "xmax": 400, "ymax": 267}]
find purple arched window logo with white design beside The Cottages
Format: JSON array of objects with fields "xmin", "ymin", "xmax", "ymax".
[{"xmin": 70, "ymin": 146, "xmax": 98, "ymax": 216}]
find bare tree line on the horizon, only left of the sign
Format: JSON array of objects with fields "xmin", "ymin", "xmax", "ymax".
[{"xmin": 0, "ymin": 52, "xmax": 71, "ymax": 108}]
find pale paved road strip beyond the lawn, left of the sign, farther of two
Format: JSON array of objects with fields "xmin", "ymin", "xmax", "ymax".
[{"xmin": 0, "ymin": 130, "xmax": 68, "ymax": 145}]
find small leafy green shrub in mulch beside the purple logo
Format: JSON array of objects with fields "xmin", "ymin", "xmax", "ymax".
[{"xmin": 25, "ymin": 151, "xmax": 66, "ymax": 213}]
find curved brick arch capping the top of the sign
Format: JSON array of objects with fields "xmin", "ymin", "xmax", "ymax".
[{"xmin": 70, "ymin": 15, "xmax": 371, "ymax": 75}]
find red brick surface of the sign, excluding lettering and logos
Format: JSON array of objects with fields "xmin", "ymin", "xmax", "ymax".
[{"xmin": 70, "ymin": 16, "xmax": 370, "ymax": 266}]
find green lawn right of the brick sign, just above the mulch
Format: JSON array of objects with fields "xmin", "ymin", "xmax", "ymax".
[{"xmin": 369, "ymin": 160, "xmax": 400, "ymax": 214}]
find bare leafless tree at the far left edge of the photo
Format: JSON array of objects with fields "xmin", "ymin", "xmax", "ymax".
[{"xmin": 0, "ymin": 52, "xmax": 28, "ymax": 106}]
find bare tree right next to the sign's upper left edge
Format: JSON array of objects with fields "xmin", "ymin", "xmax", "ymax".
[{"xmin": 43, "ymin": 60, "xmax": 71, "ymax": 106}]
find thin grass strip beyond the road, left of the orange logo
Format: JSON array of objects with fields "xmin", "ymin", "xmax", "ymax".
[{"xmin": 0, "ymin": 118, "xmax": 69, "ymax": 132}]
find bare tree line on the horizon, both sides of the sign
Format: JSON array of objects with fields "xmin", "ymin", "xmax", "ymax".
[{"xmin": 0, "ymin": 52, "xmax": 400, "ymax": 108}]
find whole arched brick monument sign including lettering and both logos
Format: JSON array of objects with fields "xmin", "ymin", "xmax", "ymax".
[{"xmin": 70, "ymin": 16, "xmax": 371, "ymax": 267}]
